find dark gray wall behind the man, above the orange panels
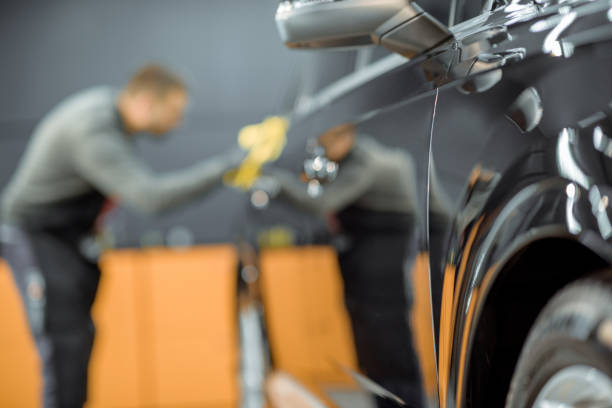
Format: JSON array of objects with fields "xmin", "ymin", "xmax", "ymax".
[{"xmin": 0, "ymin": 0, "xmax": 332, "ymax": 245}]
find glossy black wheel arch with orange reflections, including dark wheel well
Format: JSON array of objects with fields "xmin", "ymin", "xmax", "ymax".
[{"xmin": 438, "ymin": 177, "xmax": 612, "ymax": 407}]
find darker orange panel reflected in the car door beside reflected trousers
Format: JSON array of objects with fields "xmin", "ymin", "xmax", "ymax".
[{"xmin": 260, "ymin": 247, "xmax": 357, "ymax": 386}]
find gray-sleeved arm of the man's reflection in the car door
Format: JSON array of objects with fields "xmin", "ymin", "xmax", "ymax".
[{"xmin": 264, "ymin": 159, "xmax": 374, "ymax": 214}]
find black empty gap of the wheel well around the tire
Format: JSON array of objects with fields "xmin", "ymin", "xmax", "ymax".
[{"xmin": 461, "ymin": 237, "xmax": 610, "ymax": 408}]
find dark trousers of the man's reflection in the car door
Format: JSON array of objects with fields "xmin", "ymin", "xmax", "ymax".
[{"xmin": 339, "ymin": 210, "xmax": 424, "ymax": 408}]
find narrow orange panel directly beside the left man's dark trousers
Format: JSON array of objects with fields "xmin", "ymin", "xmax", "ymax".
[{"xmin": 87, "ymin": 251, "xmax": 145, "ymax": 408}]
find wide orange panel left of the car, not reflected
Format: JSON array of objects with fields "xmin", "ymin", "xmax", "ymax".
[{"xmin": 146, "ymin": 246, "xmax": 239, "ymax": 407}]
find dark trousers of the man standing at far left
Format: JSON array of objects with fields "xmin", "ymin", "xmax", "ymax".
[{"xmin": 2, "ymin": 226, "xmax": 100, "ymax": 408}]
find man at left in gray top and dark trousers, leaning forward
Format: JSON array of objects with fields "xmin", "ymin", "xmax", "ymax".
[{"xmin": 1, "ymin": 65, "xmax": 242, "ymax": 408}]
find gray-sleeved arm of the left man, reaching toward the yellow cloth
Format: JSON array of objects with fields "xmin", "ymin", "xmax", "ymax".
[{"xmin": 75, "ymin": 134, "xmax": 243, "ymax": 213}]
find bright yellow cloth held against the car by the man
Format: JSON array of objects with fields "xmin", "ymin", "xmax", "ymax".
[{"xmin": 223, "ymin": 116, "xmax": 289, "ymax": 190}]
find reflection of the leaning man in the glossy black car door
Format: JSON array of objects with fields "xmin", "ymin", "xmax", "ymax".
[{"xmin": 264, "ymin": 124, "xmax": 423, "ymax": 407}]
